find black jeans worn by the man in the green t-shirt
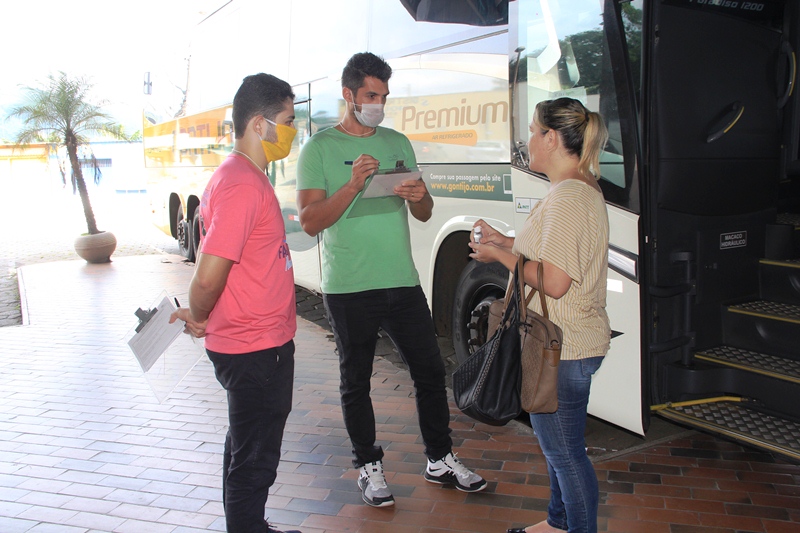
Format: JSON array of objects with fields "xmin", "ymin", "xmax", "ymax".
[{"xmin": 323, "ymin": 286, "xmax": 453, "ymax": 468}]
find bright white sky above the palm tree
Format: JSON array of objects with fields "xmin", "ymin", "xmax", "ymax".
[{"xmin": 0, "ymin": 0, "xmax": 227, "ymax": 142}]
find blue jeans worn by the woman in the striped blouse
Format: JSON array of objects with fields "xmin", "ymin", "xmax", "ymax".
[{"xmin": 531, "ymin": 357, "xmax": 603, "ymax": 533}]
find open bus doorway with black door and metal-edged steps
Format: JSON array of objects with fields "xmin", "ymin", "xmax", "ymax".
[{"xmin": 642, "ymin": 0, "xmax": 800, "ymax": 459}]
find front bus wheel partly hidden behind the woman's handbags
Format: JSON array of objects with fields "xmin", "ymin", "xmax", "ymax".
[{"xmin": 453, "ymin": 261, "xmax": 509, "ymax": 363}]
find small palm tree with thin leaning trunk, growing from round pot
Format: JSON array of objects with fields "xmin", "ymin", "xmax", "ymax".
[{"xmin": 8, "ymin": 72, "xmax": 138, "ymax": 235}]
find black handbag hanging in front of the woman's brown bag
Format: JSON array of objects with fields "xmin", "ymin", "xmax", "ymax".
[{"xmin": 453, "ymin": 260, "xmax": 522, "ymax": 426}]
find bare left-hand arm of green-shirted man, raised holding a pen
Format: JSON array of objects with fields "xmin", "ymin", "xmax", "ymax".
[{"xmin": 297, "ymin": 155, "xmax": 379, "ymax": 237}]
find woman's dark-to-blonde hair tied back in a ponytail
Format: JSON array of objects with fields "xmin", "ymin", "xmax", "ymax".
[{"xmin": 533, "ymin": 98, "xmax": 608, "ymax": 179}]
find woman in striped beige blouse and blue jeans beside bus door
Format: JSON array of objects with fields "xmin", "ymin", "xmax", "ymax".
[{"xmin": 470, "ymin": 98, "xmax": 611, "ymax": 533}]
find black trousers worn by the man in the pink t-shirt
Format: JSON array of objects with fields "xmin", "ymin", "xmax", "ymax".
[{"xmin": 207, "ymin": 341, "xmax": 294, "ymax": 533}]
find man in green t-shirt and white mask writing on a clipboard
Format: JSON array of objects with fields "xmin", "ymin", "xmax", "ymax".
[{"xmin": 297, "ymin": 53, "xmax": 486, "ymax": 507}]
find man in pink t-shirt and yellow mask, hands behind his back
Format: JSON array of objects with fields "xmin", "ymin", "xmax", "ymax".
[{"xmin": 172, "ymin": 74, "xmax": 299, "ymax": 533}]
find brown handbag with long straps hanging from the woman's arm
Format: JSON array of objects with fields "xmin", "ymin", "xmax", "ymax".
[{"xmin": 489, "ymin": 255, "xmax": 563, "ymax": 413}]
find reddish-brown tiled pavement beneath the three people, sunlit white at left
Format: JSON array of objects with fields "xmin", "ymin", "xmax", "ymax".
[{"xmin": 0, "ymin": 256, "xmax": 800, "ymax": 533}]
